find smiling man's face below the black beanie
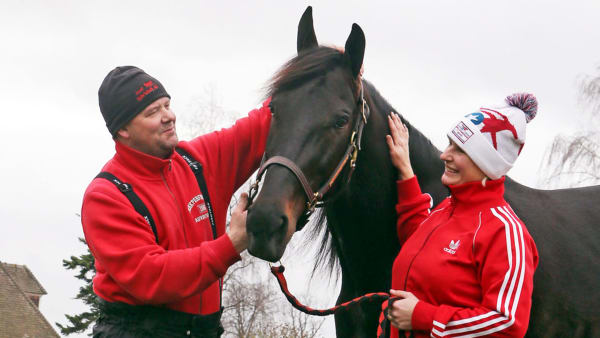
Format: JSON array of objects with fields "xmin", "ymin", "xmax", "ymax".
[{"xmin": 118, "ymin": 97, "xmax": 179, "ymax": 158}]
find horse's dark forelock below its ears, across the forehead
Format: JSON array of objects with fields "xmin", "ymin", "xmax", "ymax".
[{"xmin": 266, "ymin": 46, "xmax": 358, "ymax": 97}]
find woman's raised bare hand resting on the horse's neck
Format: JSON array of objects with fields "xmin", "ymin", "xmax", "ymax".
[{"xmin": 385, "ymin": 112, "xmax": 415, "ymax": 180}]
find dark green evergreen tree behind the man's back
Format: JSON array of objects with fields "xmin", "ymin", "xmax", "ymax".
[{"xmin": 56, "ymin": 238, "xmax": 99, "ymax": 335}]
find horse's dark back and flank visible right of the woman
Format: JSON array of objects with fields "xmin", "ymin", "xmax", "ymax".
[{"xmin": 505, "ymin": 179, "xmax": 600, "ymax": 337}]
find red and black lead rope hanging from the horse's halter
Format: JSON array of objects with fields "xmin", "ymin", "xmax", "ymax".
[{"xmin": 271, "ymin": 265, "xmax": 398, "ymax": 338}]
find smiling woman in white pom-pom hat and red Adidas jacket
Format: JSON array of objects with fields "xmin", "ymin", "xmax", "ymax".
[{"xmin": 386, "ymin": 94, "xmax": 538, "ymax": 337}]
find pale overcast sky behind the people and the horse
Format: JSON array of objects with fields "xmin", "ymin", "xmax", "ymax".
[{"xmin": 0, "ymin": 0, "xmax": 600, "ymax": 336}]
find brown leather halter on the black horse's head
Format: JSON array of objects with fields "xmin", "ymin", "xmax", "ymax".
[{"xmin": 248, "ymin": 80, "xmax": 371, "ymax": 231}]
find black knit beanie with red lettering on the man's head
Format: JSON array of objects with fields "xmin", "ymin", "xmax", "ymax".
[{"xmin": 98, "ymin": 66, "xmax": 171, "ymax": 137}]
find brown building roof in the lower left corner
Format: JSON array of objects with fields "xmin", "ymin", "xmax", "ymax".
[{"xmin": 0, "ymin": 262, "xmax": 59, "ymax": 337}]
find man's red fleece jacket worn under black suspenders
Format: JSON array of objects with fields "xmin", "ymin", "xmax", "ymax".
[{"xmin": 81, "ymin": 100, "xmax": 271, "ymax": 314}]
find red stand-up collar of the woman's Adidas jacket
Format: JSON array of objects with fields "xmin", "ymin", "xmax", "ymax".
[{"xmin": 448, "ymin": 176, "xmax": 504, "ymax": 208}]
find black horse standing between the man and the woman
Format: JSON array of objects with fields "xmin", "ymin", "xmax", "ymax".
[{"xmin": 247, "ymin": 7, "xmax": 600, "ymax": 337}]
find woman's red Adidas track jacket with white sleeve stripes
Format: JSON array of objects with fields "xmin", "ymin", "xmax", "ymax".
[{"xmin": 391, "ymin": 177, "xmax": 538, "ymax": 337}]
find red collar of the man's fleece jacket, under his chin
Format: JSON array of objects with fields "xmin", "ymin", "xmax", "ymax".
[{"xmin": 114, "ymin": 141, "xmax": 175, "ymax": 177}]
